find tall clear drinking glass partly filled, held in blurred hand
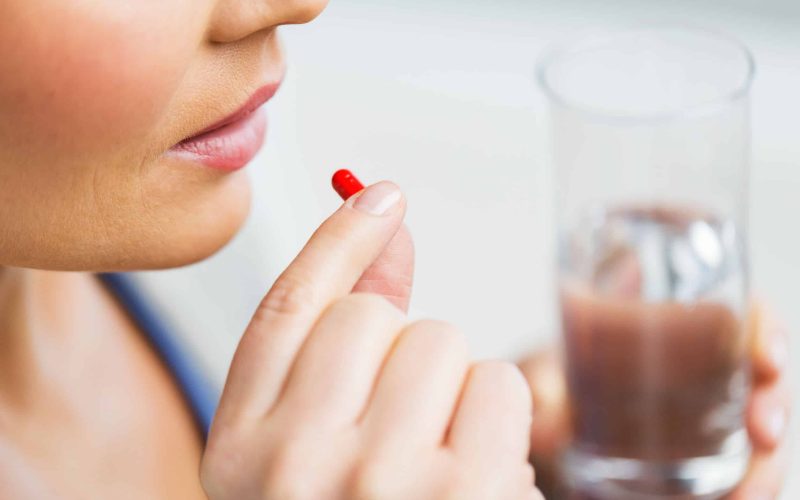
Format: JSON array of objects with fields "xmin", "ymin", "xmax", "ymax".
[{"xmin": 538, "ymin": 26, "xmax": 754, "ymax": 500}]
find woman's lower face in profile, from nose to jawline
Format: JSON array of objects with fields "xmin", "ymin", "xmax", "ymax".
[{"xmin": 0, "ymin": 0, "xmax": 327, "ymax": 270}]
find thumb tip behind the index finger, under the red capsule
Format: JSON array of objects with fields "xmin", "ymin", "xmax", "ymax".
[{"xmin": 353, "ymin": 225, "xmax": 414, "ymax": 312}]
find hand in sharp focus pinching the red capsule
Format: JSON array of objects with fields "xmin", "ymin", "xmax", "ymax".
[{"xmin": 201, "ymin": 182, "xmax": 542, "ymax": 500}]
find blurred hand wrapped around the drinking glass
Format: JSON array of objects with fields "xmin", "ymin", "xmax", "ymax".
[{"xmin": 520, "ymin": 307, "xmax": 791, "ymax": 500}]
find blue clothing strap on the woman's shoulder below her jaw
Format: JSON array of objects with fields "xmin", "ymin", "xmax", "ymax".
[{"xmin": 99, "ymin": 273, "xmax": 219, "ymax": 437}]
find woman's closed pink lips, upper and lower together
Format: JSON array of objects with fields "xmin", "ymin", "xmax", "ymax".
[{"xmin": 169, "ymin": 82, "xmax": 280, "ymax": 171}]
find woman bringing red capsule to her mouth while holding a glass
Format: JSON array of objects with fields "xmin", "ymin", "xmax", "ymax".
[{"xmin": 0, "ymin": 0, "xmax": 787, "ymax": 500}]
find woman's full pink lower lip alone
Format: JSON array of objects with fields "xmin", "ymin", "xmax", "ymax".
[{"xmin": 169, "ymin": 108, "xmax": 267, "ymax": 172}]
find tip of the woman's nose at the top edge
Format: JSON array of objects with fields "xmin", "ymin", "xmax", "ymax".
[{"xmin": 208, "ymin": 0, "xmax": 328, "ymax": 43}]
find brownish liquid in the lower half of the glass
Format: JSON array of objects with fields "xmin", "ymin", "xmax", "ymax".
[{"xmin": 562, "ymin": 290, "xmax": 748, "ymax": 460}]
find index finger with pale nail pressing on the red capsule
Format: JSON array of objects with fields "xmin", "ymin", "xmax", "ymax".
[{"xmin": 218, "ymin": 182, "xmax": 405, "ymax": 418}]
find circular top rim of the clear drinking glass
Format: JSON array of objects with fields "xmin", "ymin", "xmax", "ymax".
[{"xmin": 536, "ymin": 23, "xmax": 756, "ymax": 123}]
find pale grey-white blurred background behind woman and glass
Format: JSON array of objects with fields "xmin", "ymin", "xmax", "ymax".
[{"xmin": 138, "ymin": 0, "xmax": 800, "ymax": 499}]
